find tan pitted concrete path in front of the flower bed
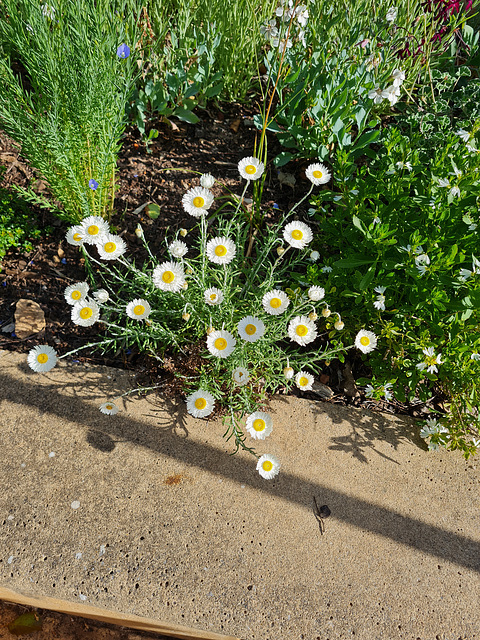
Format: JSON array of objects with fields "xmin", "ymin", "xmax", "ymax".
[{"xmin": 0, "ymin": 351, "xmax": 480, "ymax": 640}]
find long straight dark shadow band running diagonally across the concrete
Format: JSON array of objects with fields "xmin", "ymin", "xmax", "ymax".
[{"xmin": 0, "ymin": 368, "xmax": 480, "ymax": 571}]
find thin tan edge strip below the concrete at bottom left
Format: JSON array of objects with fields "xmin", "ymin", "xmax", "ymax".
[{"xmin": 0, "ymin": 587, "xmax": 240, "ymax": 640}]
